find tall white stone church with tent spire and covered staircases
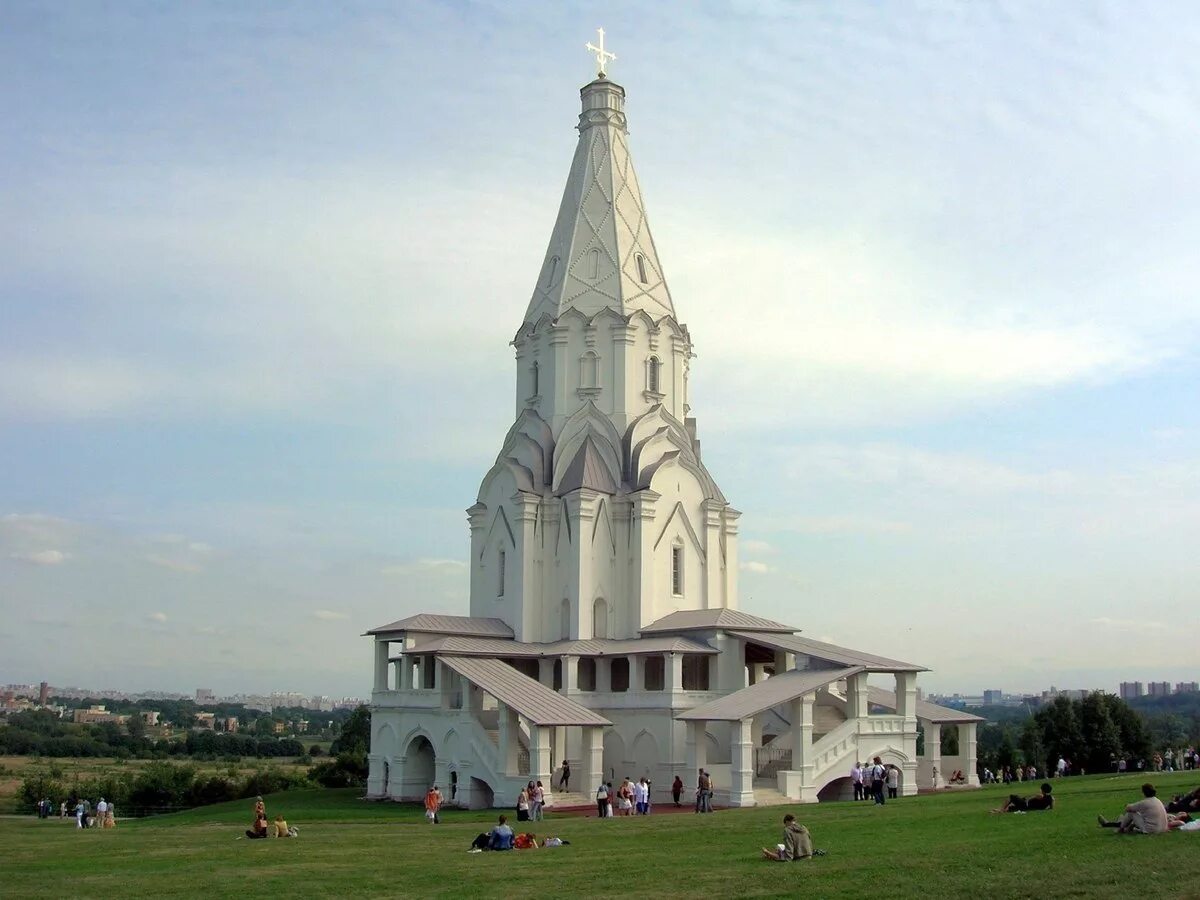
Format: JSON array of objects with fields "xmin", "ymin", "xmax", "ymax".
[{"xmin": 367, "ymin": 48, "xmax": 979, "ymax": 808}]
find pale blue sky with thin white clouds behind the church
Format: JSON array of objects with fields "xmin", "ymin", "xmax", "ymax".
[{"xmin": 0, "ymin": 0, "xmax": 1200, "ymax": 696}]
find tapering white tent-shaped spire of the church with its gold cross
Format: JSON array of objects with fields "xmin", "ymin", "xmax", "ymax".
[{"xmin": 524, "ymin": 52, "xmax": 674, "ymax": 324}]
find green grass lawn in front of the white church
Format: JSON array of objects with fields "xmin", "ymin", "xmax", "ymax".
[{"xmin": 0, "ymin": 773, "xmax": 1200, "ymax": 900}]
